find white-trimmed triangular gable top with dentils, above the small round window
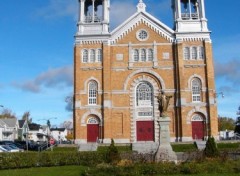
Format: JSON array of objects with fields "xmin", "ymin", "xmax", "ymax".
[{"xmin": 111, "ymin": 12, "xmax": 174, "ymax": 44}]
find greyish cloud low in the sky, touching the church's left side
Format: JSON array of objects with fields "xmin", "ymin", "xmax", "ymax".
[{"xmin": 12, "ymin": 66, "xmax": 73, "ymax": 93}]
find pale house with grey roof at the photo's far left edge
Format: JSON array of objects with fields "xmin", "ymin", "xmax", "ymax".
[{"xmin": 0, "ymin": 118, "xmax": 19, "ymax": 141}]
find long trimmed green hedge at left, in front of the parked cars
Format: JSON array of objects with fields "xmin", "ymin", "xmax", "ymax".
[{"xmin": 0, "ymin": 152, "xmax": 106, "ymax": 169}]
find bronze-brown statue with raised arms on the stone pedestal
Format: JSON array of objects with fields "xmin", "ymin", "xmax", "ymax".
[{"xmin": 157, "ymin": 91, "xmax": 172, "ymax": 117}]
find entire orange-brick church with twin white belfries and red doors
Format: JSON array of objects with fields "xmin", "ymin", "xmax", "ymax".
[{"xmin": 73, "ymin": 0, "xmax": 218, "ymax": 144}]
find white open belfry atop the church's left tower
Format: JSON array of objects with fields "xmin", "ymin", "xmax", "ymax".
[{"xmin": 77, "ymin": 0, "xmax": 110, "ymax": 35}]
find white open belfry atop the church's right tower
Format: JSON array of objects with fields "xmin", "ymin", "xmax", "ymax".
[{"xmin": 172, "ymin": 0, "xmax": 209, "ymax": 32}]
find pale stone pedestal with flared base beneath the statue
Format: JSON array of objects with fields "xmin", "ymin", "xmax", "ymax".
[{"xmin": 155, "ymin": 117, "xmax": 177, "ymax": 162}]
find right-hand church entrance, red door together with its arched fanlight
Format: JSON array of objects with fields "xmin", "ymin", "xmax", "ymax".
[{"xmin": 192, "ymin": 115, "xmax": 204, "ymax": 140}]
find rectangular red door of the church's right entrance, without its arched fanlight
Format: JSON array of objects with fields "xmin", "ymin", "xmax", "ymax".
[{"xmin": 192, "ymin": 121, "xmax": 204, "ymax": 140}]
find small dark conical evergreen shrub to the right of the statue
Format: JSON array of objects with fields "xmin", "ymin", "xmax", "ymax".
[{"xmin": 204, "ymin": 137, "xmax": 219, "ymax": 157}]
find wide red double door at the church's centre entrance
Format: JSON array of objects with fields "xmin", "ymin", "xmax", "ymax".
[{"xmin": 137, "ymin": 121, "xmax": 154, "ymax": 141}]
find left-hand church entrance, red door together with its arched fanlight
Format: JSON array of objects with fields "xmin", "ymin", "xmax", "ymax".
[{"xmin": 87, "ymin": 118, "xmax": 99, "ymax": 142}]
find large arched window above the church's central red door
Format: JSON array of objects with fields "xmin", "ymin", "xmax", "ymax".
[{"xmin": 136, "ymin": 82, "xmax": 153, "ymax": 107}]
